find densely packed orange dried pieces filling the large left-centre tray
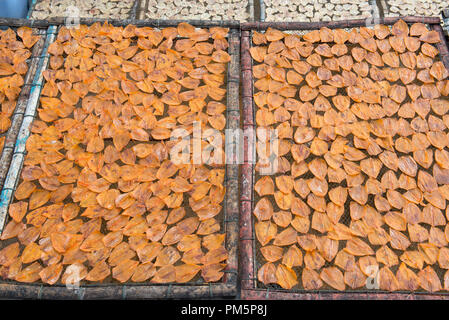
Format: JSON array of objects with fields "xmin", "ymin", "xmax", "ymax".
[{"xmin": 0, "ymin": 23, "xmax": 230, "ymax": 284}]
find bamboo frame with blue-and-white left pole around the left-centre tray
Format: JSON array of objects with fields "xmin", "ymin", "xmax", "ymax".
[{"xmin": 0, "ymin": 18, "xmax": 240, "ymax": 299}]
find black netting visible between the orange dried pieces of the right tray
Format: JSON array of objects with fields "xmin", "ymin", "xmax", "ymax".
[{"xmin": 251, "ymin": 27, "xmax": 449, "ymax": 292}]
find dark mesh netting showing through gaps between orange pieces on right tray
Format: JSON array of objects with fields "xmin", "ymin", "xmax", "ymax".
[{"xmin": 251, "ymin": 26, "xmax": 449, "ymax": 292}]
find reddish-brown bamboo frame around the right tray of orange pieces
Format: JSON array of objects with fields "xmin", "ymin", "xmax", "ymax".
[{"xmin": 240, "ymin": 17, "xmax": 449, "ymax": 300}]
